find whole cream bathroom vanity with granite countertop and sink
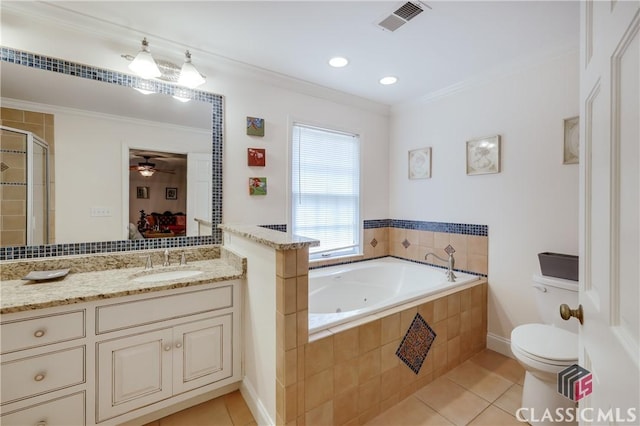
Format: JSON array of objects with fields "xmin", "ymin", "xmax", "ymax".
[{"xmin": 0, "ymin": 248, "xmax": 246, "ymax": 426}]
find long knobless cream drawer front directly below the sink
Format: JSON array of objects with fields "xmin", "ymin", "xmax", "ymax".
[{"xmin": 96, "ymin": 283, "xmax": 233, "ymax": 334}]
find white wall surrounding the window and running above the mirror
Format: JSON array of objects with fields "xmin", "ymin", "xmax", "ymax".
[{"xmin": 2, "ymin": 6, "xmax": 389, "ymax": 231}]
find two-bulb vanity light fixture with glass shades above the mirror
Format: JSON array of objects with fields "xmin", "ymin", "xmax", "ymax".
[{"xmin": 121, "ymin": 37, "xmax": 206, "ymax": 89}]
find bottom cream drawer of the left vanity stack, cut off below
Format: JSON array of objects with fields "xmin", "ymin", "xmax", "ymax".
[{"xmin": 0, "ymin": 392, "xmax": 86, "ymax": 426}]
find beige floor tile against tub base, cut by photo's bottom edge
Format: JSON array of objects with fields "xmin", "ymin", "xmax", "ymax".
[{"xmin": 365, "ymin": 396, "xmax": 453, "ymax": 426}]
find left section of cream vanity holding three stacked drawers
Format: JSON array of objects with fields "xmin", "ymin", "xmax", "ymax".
[{"xmin": 0, "ymin": 309, "xmax": 87, "ymax": 426}]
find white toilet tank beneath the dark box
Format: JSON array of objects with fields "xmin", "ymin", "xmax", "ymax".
[{"xmin": 532, "ymin": 274, "xmax": 579, "ymax": 333}]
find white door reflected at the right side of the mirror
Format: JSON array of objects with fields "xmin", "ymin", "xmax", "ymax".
[{"xmin": 187, "ymin": 153, "xmax": 212, "ymax": 236}]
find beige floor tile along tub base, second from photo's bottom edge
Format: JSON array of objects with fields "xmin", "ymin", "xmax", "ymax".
[{"xmin": 415, "ymin": 376, "xmax": 489, "ymax": 425}]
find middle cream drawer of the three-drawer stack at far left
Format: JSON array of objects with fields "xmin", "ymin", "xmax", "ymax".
[{"xmin": 0, "ymin": 346, "xmax": 85, "ymax": 404}]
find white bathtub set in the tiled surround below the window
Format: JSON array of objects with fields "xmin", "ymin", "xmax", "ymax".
[{"xmin": 309, "ymin": 257, "xmax": 479, "ymax": 333}]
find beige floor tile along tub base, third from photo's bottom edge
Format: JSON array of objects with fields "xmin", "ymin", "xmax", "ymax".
[{"xmin": 445, "ymin": 361, "xmax": 513, "ymax": 402}]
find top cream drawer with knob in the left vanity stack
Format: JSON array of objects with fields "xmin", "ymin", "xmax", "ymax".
[{"xmin": 0, "ymin": 310, "xmax": 85, "ymax": 354}]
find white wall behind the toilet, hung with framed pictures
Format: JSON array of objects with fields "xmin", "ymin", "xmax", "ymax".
[{"xmin": 389, "ymin": 52, "xmax": 579, "ymax": 339}]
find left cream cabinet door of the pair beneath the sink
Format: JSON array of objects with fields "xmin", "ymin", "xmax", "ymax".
[{"xmin": 96, "ymin": 328, "xmax": 173, "ymax": 421}]
